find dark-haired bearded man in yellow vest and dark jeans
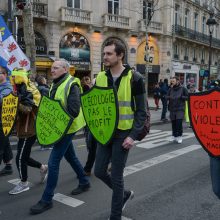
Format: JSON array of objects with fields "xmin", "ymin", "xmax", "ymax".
[{"xmin": 95, "ymin": 39, "xmax": 146, "ymax": 220}]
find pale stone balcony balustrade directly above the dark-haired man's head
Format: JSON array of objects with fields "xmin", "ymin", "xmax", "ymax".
[{"xmin": 103, "ymin": 14, "xmax": 131, "ymax": 30}]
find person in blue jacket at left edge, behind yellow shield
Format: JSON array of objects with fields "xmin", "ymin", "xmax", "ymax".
[{"xmin": 0, "ymin": 66, "xmax": 13, "ymax": 176}]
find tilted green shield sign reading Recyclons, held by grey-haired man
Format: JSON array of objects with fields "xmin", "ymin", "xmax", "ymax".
[{"xmin": 36, "ymin": 96, "xmax": 72, "ymax": 146}]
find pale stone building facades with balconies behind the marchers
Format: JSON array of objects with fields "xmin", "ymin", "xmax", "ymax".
[{"xmin": 0, "ymin": 0, "xmax": 220, "ymax": 92}]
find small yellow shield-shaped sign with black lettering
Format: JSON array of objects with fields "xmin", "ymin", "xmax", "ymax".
[{"xmin": 1, "ymin": 93, "xmax": 18, "ymax": 136}]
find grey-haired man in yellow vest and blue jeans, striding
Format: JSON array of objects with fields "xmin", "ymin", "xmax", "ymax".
[{"xmin": 30, "ymin": 59, "xmax": 90, "ymax": 214}]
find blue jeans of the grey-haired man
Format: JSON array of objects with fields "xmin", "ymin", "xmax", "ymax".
[{"xmin": 41, "ymin": 134, "xmax": 89, "ymax": 202}]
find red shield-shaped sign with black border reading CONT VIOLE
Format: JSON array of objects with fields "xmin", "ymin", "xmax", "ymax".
[{"xmin": 189, "ymin": 89, "xmax": 220, "ymax": 157}]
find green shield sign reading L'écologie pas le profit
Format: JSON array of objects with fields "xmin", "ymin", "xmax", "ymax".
[{"xmin": 81, "ymin": 86, "xmax": 118, "ymax": 145}]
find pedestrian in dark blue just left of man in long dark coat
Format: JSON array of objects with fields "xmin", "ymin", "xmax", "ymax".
[{"xmin": 160, "ymin": 79, "xmax": 169, "ymax": 122}]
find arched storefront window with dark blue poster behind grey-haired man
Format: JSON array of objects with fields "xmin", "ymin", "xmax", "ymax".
[{"xmin": 59, "ymin": 32, "xmax": 91, "ymax": 78}]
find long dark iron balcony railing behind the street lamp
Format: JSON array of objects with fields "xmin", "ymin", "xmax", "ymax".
[{"xmin": 173, "ymin": 25, "xmax": 220, "ymax": 48}]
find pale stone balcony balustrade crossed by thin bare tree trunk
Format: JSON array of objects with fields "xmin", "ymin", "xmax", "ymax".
[{"xmin": 138, "ymin": 19, "xmax": 163, "ymax": 34}]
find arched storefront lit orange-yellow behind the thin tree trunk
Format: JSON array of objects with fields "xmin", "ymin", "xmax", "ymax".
[{"xmin": 136, "ymin": 36, "xmax": 160, "ymax": 94}]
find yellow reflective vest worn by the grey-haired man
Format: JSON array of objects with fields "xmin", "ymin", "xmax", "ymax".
[{"xmin": 50, "ymin": 75, "xmax": 86, "ymax": 134}]
